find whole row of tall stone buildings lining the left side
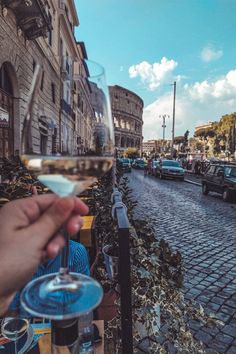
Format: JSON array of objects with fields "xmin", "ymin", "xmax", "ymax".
[{"xmin": 0, "ymin": 0, "xmax": 94, "ymax": 157}]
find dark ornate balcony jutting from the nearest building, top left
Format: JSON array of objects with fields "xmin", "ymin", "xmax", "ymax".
[{"xmin": 0, "ymin": 0, "xmax": 52, "ymax": 40}]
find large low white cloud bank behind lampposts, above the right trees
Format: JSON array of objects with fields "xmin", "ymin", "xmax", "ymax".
[{"xmin": 143, "ymin": 69, "xmax": 236, "ymax": 140}]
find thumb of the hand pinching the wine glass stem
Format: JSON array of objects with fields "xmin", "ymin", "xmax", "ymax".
[{"xmin": 28, "ymin": 197, "xmax": 75, "ymax": 249}]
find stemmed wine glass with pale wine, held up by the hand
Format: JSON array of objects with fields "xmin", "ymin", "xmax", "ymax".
[{"xmin": 21, "ymin": 60, "xmax": 114, "ymax": 320}]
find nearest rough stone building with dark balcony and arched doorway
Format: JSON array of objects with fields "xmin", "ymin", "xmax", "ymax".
[{"xmin": 0, "ymin": 1, "xmax": 60, "ymax": 157}]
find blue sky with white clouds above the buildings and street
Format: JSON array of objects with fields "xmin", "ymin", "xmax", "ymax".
[{"xmin": 74, "ymin": 0, "xmax": 236, "ymax": 141}]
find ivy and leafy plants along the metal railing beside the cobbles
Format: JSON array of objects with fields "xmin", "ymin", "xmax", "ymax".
[{"xmin": 93, "ymin": 169, "xmax": 221, "ymax": 354}]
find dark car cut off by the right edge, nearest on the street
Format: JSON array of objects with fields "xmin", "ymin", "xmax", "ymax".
[{"xmin": 202, "ymin": 163, "xmax": 236, "ymax": 202}]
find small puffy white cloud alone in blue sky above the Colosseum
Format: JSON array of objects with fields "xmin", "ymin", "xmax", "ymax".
[{"xmin": 129, "ymin": 57, "xmax": 178, "ymax": 91}]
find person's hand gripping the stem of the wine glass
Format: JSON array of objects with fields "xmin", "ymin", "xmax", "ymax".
[{"xmin": 0, "ymin": 194, "xmax": 88, "ymax": 313}]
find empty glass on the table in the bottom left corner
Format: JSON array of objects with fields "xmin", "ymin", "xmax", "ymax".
[{"xmin": 1, "ymin": 317, "xmax": 29, "ymax": 354}]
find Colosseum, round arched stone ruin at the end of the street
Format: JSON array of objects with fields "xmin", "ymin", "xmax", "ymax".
[{"xmin": 109, "ymin": 85, "xmax": 143, "ymax": 154}]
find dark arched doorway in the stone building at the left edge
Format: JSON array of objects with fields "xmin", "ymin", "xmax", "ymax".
[{"xmin": 0, "ymin": 61, "xmax": 20, "ymax": 157}]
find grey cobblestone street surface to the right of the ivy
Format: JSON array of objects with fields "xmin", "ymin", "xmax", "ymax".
[{"xmin": 129, "ymin": 170, "xmax": 236, "ymax": 354}]
